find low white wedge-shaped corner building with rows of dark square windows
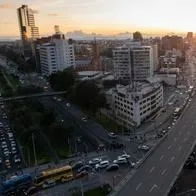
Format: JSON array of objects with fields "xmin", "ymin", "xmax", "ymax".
[{"xmin": 109, "ymin": 81, "xmax": 163, "ymax": 129}]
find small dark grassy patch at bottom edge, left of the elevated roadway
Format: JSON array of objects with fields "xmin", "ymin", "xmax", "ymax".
[{"xmin": 72, "ymin": 185, "xmax": 111, "ymax": 196}]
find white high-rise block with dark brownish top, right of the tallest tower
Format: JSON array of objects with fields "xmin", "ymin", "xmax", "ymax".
[{"xmin": 39, "ymin": 34, "xmax": 75, "ymax": 76}]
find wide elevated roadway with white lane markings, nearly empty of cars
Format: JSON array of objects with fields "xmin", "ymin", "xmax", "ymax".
[{"xmin": 111, "ymin": 96, "xmax": 196, "ymax": 196}]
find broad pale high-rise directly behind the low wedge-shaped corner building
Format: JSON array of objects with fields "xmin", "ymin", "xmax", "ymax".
[{"xmin": 113, "ymin": 42, "xmax": 153, "ymax": 81}]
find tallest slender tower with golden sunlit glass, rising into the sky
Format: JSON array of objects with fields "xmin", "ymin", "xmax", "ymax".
[{"xmin": 17, "ymin": 5, "xmax": 39, "ymax": 58}]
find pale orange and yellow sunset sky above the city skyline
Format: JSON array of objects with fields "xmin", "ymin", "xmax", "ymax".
[{"xmin": 0, "ymin": 0, "xmax": 196, "ymax": 36}]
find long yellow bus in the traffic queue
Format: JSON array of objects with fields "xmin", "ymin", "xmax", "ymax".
[{"xmin": 34, "ymin": 165, "xmax": 74, "ymax": 187}]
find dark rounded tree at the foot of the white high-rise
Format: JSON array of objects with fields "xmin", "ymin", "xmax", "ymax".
[{"xmin": 49, "ymin": 68, "xmax": 76, "ymax": 91}]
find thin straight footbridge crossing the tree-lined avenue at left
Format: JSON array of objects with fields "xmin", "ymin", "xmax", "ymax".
[{"xmin": 0, "ymin": 91, "xmax": 67, "ymax": 102}]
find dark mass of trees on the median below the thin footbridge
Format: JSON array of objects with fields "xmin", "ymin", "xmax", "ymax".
[{"xmin": 8, "ymin": 99, "xmax": 73, "ymax": 161}]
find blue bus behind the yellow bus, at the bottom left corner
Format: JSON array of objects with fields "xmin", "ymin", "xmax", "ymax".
[{"xmin": 0, "ymin": 174, "xmax": 33, "ymax": 195}]
